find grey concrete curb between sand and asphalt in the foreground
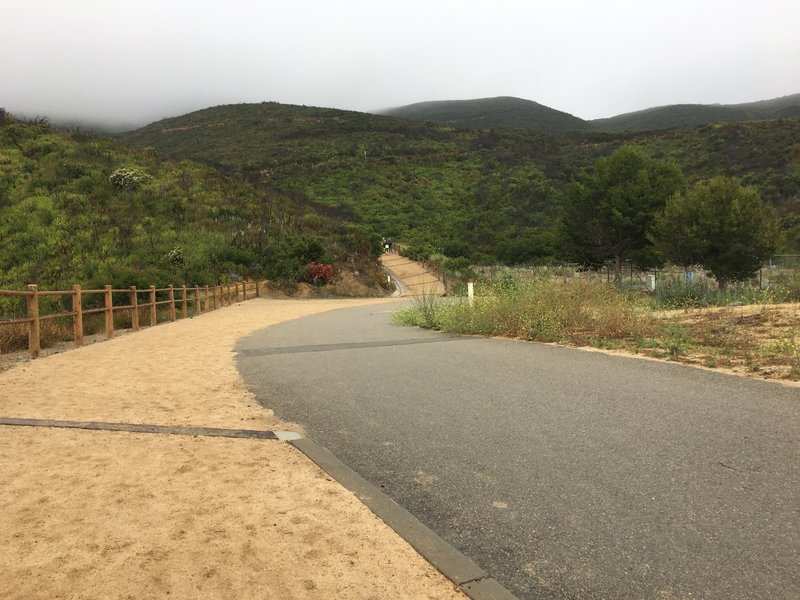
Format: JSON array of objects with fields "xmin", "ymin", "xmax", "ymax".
[{"xmin": 288, "ymin": 438, "xmax": 517, "ymax": 600}]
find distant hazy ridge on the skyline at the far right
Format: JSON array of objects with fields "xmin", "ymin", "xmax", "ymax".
[{"xmin": 589, "ymin": 94, "xmax": 800, "ymax": 131}]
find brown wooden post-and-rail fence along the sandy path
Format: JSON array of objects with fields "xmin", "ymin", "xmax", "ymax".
[{"xmin": 0, "ymin": 281, "xmax": 266, "ymax": 358}]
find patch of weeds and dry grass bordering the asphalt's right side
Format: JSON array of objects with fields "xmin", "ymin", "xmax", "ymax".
[{"xmin": 395, "ymin": 279, "xmax": 800, "ymax": 381}]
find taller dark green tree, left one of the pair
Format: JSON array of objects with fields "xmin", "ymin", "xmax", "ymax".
[{"xmin": 561, "ymin": 146, "xmax": 684, "ymax": 283}]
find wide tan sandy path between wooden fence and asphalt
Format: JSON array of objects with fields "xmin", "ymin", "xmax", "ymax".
[{"xmin": 0, "ymin": 299, "xmax": 463, "ymax": 600}]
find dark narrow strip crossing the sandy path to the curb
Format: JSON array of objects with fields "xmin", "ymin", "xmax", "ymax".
[{"xmin": 0, "ymin": 417, "xmax": 292, "ymax": 441}]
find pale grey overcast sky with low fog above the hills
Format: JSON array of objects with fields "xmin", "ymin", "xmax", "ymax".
[{"xmin": 6, "ymin": 0, "xmax": 800, "ymax": 124}]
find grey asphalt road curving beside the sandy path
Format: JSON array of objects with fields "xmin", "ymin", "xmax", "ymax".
[{"xmin": 237, "ymin": 305, "xmax": 800, "ymax": 600}]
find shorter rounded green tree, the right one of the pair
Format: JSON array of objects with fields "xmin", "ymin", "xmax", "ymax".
[{"xmin": 652, "ymin": 177, "xmax": 780, "ymax": 289}]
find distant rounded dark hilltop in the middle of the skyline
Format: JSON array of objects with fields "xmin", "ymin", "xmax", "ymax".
[{"xmin": 379, "ymin": 96, "xmax": 588, "ymax": 133}]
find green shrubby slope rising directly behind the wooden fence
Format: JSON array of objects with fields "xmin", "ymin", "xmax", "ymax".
[{"xmin": 0, "ymin": 111, "xmax": 382, "ymax": 289}]
